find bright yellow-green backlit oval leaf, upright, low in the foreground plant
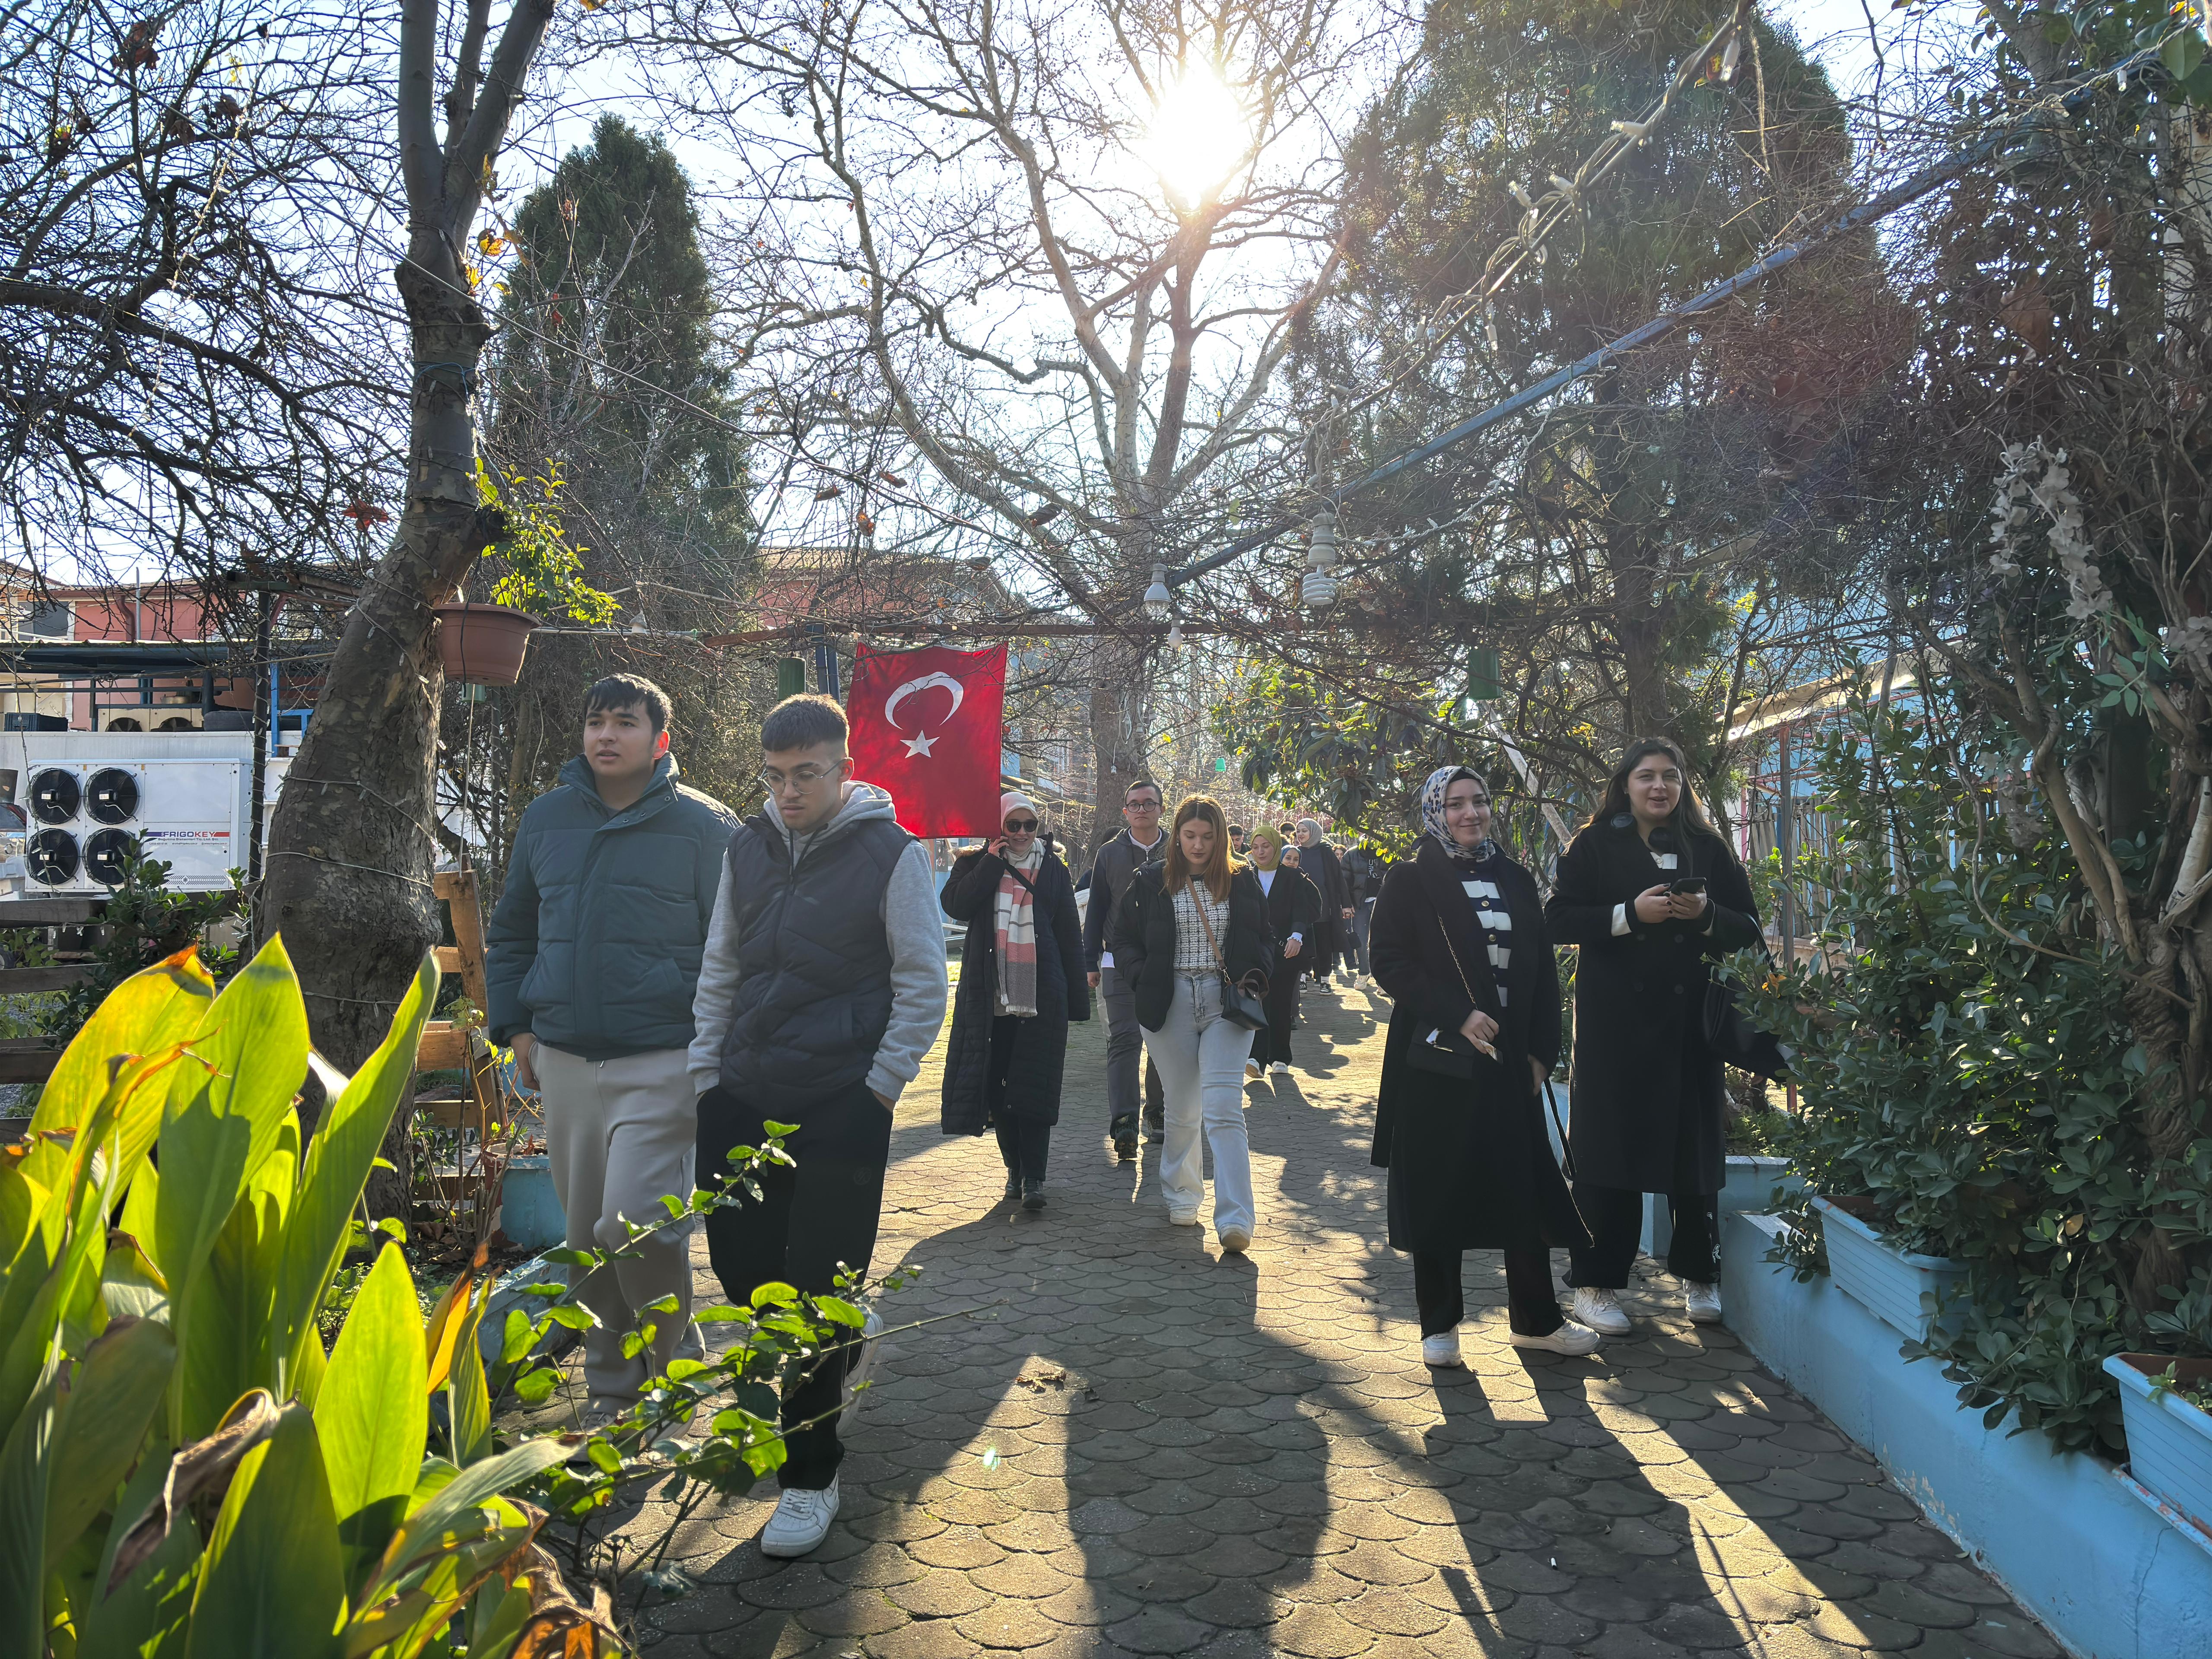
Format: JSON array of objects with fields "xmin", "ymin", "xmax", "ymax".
[{"xmin": 314, "ymin": 1243, "xmax": 429, "ymax": 1580}]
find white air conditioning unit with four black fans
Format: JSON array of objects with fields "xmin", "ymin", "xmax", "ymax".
[{"xmin": 0, "ymin": 739, "xmax": 252, "ymax": 893}]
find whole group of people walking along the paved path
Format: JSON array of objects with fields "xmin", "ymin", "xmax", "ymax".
[{"xmin": 486, "ymin": 675, "xmax": 1758, "ymax": 1555}]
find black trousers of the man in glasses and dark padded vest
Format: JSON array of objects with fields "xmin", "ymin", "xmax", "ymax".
[{"xmin": 699, "ymin": 1088, "xmax": 883, "ymax": 1491}]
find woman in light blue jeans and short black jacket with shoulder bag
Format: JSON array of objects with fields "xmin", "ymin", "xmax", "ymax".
[{"xmin": 1112, "ymin": 794, "xmax": 1276, "ymax": 1254}]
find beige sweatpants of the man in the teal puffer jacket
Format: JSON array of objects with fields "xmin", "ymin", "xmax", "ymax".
[{"xmin": 535, "ymin": 1042, "xmax": 706, "ymax": 1407}]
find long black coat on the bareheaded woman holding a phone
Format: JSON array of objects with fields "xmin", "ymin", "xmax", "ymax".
[{"xmin": 1544, "ymin": 812, "xmax": 1758, "ymax": 1197}]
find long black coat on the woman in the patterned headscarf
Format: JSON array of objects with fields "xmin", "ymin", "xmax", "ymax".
[{"xmin": 1367, "ymin": 836, "xmax": 1586, "ymax": 1250}]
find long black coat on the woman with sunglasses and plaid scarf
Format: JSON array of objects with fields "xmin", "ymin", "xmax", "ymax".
[{"xmin": 938, "ymin": 845, "xmax": 1090, "ymax": 1135}]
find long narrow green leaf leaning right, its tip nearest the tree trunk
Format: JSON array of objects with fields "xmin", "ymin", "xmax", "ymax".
[{"xmin": 272, "ymin": 951, "xmax": 438, "ymax": 1387}]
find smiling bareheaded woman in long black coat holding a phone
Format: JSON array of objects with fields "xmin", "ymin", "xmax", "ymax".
[{"xmin": 1544, "ymin": 737, "xmax": 1758, "ymax": 1336}]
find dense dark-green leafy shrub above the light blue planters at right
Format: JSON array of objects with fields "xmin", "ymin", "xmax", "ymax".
[{"xmin": 1736, "ymin": 699, "xmax": 2212, "ymax": 1453}]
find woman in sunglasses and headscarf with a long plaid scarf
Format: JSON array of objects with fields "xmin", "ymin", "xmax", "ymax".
[{"xmin": 940, "ymin": 792, "xmax": 1090, "ymax": 1210}]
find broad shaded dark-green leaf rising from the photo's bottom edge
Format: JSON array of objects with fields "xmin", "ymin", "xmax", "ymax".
[{"xmin": 186, "ymin": 1405, "xmax": 345, "ymax": 1659}]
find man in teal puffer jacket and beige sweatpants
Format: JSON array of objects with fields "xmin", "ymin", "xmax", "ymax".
[{"xmin": 484, "ymin": 675, "xmax": 737, "ymax": 1424}]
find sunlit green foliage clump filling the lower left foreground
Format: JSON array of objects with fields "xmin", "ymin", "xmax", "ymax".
[{"xmin": 0, "ymin": 940, "xmax": 898, "ymax": 1659}]
